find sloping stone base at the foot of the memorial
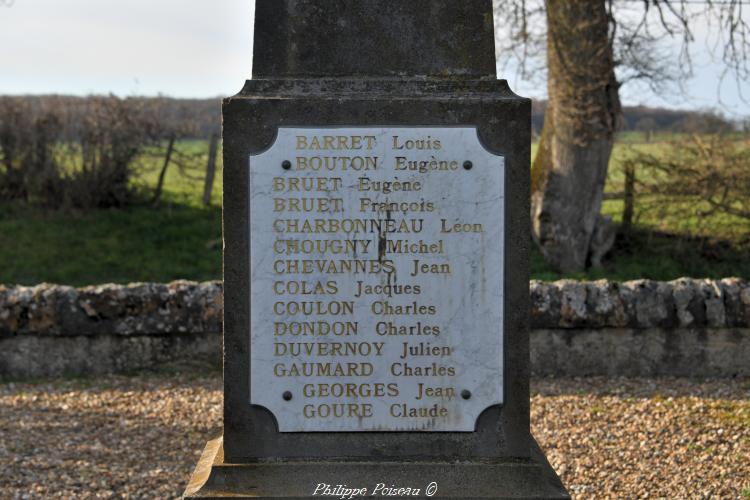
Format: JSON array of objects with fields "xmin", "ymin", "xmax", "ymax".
[{"xmin": 184, "ymin": 436, "xmax": 570, "ymax": 499}]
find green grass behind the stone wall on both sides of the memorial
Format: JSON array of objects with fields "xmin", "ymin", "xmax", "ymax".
[{"xmin": 0, "ymin": 136, "xmax": 750, "ymax": 286}]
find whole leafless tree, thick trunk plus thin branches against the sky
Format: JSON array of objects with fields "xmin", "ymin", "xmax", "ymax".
[{"xmin": 495, "ymin": 0, "xmax": 750, "ymax": 272}]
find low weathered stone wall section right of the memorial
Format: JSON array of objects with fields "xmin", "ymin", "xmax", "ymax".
[{"xmin": 530, "ymin": 278, "xmax": 750, "ymax": 377}]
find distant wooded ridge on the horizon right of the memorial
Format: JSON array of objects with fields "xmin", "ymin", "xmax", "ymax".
[{"xmin": 531, "ymin": 101, "xmax": 741, "ymax": 134}]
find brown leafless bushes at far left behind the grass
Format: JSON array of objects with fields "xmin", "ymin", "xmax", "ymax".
[{"xmin": 0, "ymin": 97, "xmax": 159, "ymax": 209}]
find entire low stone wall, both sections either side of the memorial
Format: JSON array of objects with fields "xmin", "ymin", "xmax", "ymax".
[{"xmin": 0, "ymin": 279, "xmax": 750, "ymax": 378}]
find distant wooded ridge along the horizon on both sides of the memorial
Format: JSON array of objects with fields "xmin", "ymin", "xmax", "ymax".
[{"xmin": 0, "ymin": 96, "xmax": 738, "ymax": 139}]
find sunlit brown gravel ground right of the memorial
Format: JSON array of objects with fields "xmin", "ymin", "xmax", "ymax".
[{"xmin": 531, "ymin": 378, "xmax": 750, "ymax": 499}]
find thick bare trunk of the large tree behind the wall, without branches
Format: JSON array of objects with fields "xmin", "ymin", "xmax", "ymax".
[{"xmin": 531, "ymin": 0, "xmax": 620, "ymax": 272}]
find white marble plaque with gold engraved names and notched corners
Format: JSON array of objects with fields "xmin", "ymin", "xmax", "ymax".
[{"xmin": 248, "ymin": 127, "xmax": 505, "ymax": 432}]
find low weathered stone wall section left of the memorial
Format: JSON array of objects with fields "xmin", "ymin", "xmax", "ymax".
[{"xmin": 0, "ymin": 281, "xmax": 224, "ymax": 378}]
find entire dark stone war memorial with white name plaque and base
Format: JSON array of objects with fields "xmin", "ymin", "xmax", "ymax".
[{"xmin": 185, "ymin": 0, "xmax": 568, "ymax": 498}]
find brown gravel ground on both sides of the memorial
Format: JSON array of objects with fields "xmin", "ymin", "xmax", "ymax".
[{"xmin": 0, "ymin": 372, "xmax": 750, "ymax": 499}]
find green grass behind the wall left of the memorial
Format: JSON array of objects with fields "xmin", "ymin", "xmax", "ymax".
[{"xmin": 0, "ymin": 142, "xmax": 221, "ymax": 286}]
